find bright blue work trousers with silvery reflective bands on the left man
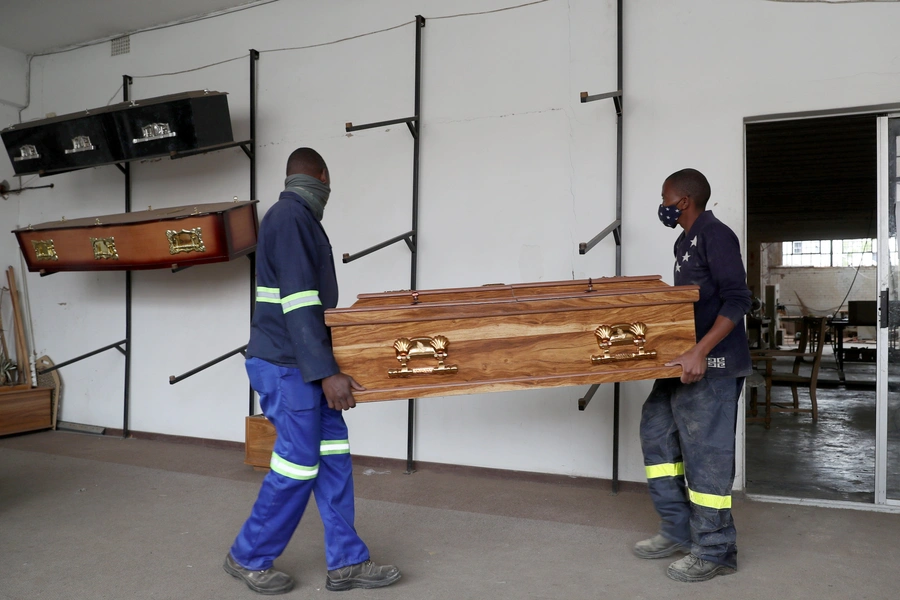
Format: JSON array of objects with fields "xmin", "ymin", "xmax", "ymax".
[{"xmin": 231, "ymin": 357, "xmax": 369, "ymax": 571}]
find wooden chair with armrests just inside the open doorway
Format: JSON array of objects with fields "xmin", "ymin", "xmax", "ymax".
[{"xmin": 751, "ymin": 317, "xmax": 828, "ymax": 427}]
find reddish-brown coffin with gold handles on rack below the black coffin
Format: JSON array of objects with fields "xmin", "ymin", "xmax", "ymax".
[{"xmin": 13, "ymin": 200, "xmax": 259, "ymax": 274}]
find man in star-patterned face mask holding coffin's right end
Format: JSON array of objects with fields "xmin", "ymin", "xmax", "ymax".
[{"xmin": 634, "ymin": 169, "xmax": 751, "ymax": 582}]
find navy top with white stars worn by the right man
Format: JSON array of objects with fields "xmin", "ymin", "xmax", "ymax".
[{"xmin": 675, "ymin": 211, "xmax": 752, "ymax": 377}]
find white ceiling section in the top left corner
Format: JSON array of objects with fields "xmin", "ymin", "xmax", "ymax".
[{"xmin": 0, "ymin": 0, "xmax": 259, "ymax": 54}]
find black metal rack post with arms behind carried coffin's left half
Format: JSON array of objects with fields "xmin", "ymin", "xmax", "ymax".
[{"xmin": 343, "ymin": 15, "xmax": 425, "ymax": 475}]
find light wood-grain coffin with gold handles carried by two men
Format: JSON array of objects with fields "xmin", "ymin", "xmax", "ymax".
[{"xmin": 325, "ymin": 276, "xmax": 699, "ymax": 402}]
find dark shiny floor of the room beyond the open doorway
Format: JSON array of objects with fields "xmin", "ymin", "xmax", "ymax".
[{"xmin": 746, "ymin": 341, "xmax": 900, "ymax": 503}]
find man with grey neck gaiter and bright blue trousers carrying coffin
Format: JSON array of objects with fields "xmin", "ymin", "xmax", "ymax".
[{"xmin": 224, "ymin": 148, "xmax": 400, "ymax": 594}]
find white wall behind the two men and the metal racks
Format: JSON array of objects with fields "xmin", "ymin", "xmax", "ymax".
[{"xmin": 20, "ymin": 0, "xmax": 900, "ymax": 480}]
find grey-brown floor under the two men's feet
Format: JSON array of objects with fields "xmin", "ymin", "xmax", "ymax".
[{"xmin": 0, "ymin": 431, "xmax": 900, "ymax": 600}]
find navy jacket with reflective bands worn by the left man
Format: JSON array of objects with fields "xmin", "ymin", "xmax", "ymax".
[{"xmin": 247, "ymin": 192, "xmax": 340, "ymax": 382}]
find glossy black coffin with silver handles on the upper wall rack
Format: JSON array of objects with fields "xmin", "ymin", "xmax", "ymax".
[{"xmin": 0, "ymin": 90, "xmax": 233, "ymax": 175}]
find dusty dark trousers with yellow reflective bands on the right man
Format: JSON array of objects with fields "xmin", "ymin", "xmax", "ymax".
[{"xmin": 641, "ymin": 377, "xmax": 744, "ymax": 568}]
